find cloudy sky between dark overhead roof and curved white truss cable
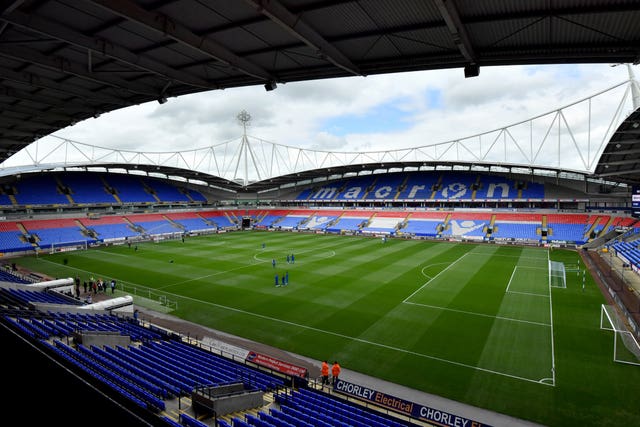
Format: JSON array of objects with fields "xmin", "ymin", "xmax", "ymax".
[{"xmin": 6, "ymin": 64, "xmax": 639, "ymax": 176}]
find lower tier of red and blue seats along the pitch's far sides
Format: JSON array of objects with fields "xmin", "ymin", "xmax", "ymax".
[{"xmin": 0, "ymin": 209, "xmax": 638, "ymax": 253}]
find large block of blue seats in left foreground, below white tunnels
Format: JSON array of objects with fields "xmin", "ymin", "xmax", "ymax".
[{"xmin": 3, "ymin": 312, "xmax": 285, "ymax": 426}]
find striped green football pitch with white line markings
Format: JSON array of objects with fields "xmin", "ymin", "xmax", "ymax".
[{"xmin": 15, "ymin": 231, "xmax": 640, "ymax": 426}]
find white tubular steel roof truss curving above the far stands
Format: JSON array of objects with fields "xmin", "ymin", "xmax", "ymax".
[{"xmin": 0, "ymin": 80, "xmax": 636, "ymax": 184}]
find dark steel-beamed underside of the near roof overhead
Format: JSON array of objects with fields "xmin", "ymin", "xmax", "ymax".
[{"xmin": 0, "ymin": 0, "xmax": 640, "ymax": 190}]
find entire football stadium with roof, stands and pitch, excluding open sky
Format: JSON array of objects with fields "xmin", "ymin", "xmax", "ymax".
[{"xmin": 0, "ymin": 0, "xmax": 640, "ymax": 427}]
